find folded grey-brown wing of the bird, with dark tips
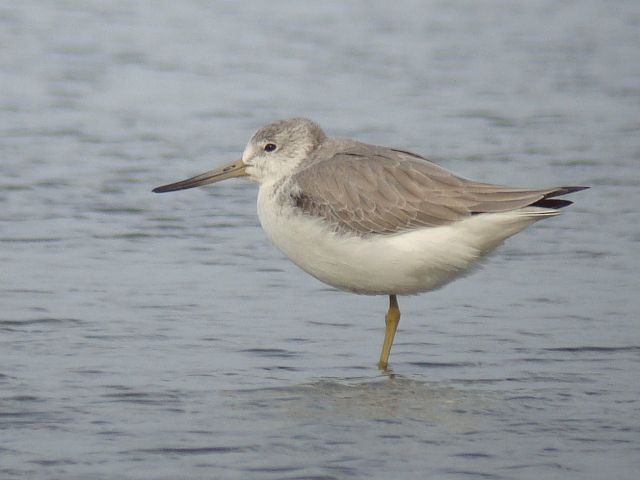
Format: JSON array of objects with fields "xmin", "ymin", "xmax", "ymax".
[{"xmin": 292, "ymin": 142, "xmax": 583, "ymax": 235}]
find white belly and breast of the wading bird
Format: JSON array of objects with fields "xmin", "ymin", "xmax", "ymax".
[{"xmin": 258, "ymin": 185, "xmax": 555, "ymax": 295}]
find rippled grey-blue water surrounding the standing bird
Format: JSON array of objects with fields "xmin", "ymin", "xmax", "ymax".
[{"xmin": 0, "ymin": 0, "xmax": 640, "ymax": 480}]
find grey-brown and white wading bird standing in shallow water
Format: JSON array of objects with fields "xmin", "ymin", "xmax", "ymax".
[{"xmin": 153, "ymin": 118, "xmax": 589, "ymax": 371}]
